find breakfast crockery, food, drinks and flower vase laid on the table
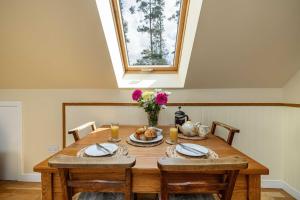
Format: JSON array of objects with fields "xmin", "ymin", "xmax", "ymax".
[{"xmin": 77, "ymin": 89, "xmax": 218, "ymax": 159}]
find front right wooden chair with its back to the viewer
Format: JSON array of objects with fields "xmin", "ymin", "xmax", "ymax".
[{"xmin": 158, "ymin": 157, "xmax": 248, "ymax": 200}]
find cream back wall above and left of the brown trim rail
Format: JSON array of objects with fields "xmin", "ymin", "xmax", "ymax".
[{"xmin": 0, "ymin": 89, "xmax": 282, "ymax": 176}]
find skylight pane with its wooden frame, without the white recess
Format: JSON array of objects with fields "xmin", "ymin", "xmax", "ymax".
[{"xmin": 112, "ymin": 0, "xmax": 188, "ymax": 71}]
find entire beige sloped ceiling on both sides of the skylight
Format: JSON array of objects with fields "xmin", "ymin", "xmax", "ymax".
[{"xmin": 0, "ymin": 0, "xmax": 300, "ymax": 88}]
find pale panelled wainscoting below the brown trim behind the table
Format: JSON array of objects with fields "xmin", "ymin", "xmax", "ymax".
[{"xmin": 66, "ymin": 106, "xmax": 284, "ymax": 180}]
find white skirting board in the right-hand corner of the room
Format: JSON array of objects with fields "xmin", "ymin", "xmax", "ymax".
[{"xmin": 261, "ymin": 180, "xmax": 300, "ymax": 199}]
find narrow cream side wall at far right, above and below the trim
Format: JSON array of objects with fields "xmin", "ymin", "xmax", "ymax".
[{"xmin": 283, "ymin": 71, "xmax": 300, "ymax": 191}]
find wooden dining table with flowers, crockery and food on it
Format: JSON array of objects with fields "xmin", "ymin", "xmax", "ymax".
[{"xmin": 34, "ymin": 90, "xmax": 269, "ymax": 199}]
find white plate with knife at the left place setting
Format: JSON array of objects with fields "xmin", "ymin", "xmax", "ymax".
[{"xmin": 84, "ymin": 143, "xmax": 119, "ymax": 156}]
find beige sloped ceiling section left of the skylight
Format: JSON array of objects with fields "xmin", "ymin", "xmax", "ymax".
[{"xmin": 0, "ymin": 0, "xmax": 117, "ymax": 89}]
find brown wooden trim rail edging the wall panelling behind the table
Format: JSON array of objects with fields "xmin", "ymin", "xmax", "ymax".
[{"xmin": 62, "ymin": 102, "xmax": 300, "ymax": 148}]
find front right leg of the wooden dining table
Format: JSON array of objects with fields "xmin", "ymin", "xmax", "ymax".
[{"xmin": 248, "ymin": 175, "xmax": 261, "ymax": 200}]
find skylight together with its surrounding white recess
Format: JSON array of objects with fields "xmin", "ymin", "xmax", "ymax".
[{"xmin": 96, "ymin": 0, "xmax": 202, "ymax": 88}]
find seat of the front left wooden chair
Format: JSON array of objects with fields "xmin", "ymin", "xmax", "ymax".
[{"xmin": 72, "ymin": 192, "xmax": 124, "ymax": 200}]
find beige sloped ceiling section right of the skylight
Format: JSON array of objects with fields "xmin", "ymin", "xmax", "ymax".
[{"xmin": 186, "ymin": 0, "xmax": 300, "ymax": 88}]
